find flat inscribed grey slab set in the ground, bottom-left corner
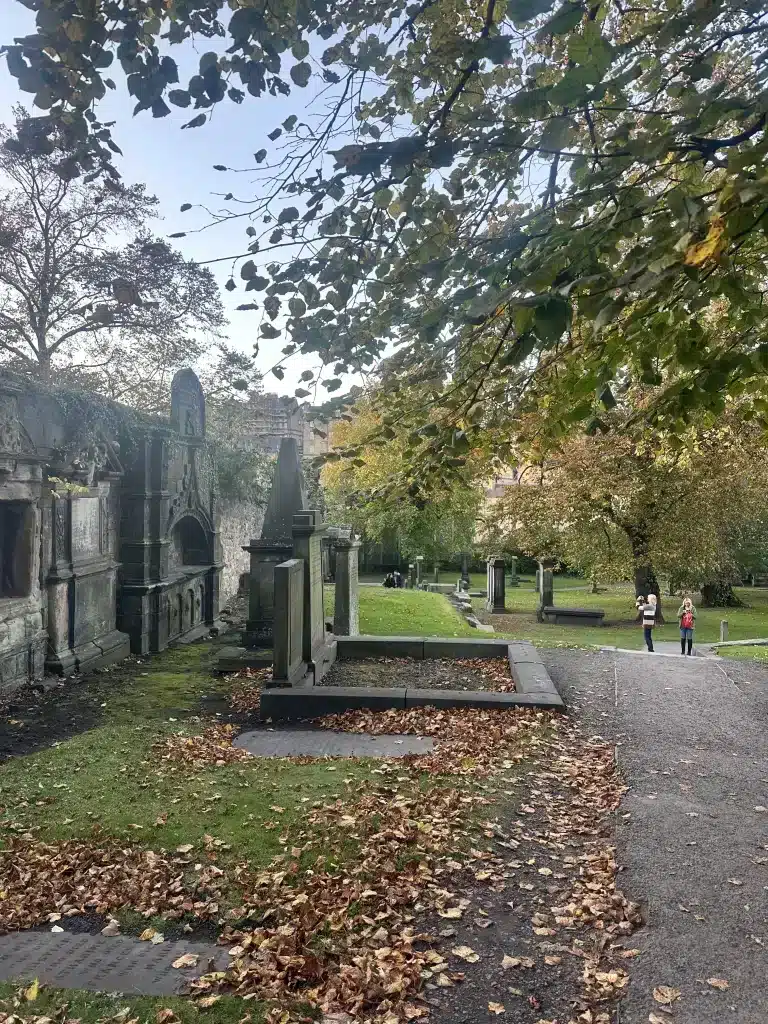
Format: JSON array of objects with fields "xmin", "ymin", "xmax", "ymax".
[{"xmin": 0, "ymin": 932, "xmax": 229, "ymax": 995}]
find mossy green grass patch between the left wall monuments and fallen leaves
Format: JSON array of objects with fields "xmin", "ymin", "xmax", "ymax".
[{"xmin": 0, "ymin": 645, "xmax": 370, "ymax": 865}]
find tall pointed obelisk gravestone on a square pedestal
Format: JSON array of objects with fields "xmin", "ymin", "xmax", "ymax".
[{"xmin": 244, "ymin": 437, "xmax": 307, "ymax": 647}]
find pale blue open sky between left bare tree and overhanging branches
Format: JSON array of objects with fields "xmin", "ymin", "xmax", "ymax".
[{"xmin": 0, "ymin": 7, "xmax": 356, "ymax": 402}]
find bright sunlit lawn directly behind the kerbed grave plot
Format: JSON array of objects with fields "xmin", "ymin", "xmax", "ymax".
[{"xmin": 325, "ymin": 587, "xmax": 477, "ymax": 637}]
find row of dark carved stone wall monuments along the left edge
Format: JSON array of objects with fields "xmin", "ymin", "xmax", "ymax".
[{"xmin": 0, "ymin": 370, "xmax": 222, "ymax": 690}]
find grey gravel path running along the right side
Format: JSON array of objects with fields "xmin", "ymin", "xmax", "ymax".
[{"xmin": 542, "ymin": 651, "xmax": 768, "ymax": 1024}]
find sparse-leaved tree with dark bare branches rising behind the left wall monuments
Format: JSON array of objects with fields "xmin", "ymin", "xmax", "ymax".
[{"xmin": 0, "ymin": 109, "xmax": 228, "ymax": 412}]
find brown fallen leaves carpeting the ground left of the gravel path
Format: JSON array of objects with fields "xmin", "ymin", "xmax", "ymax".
[{"xmin": 0, "ymin": 704, "xmax": 639, "ymax": 1024}]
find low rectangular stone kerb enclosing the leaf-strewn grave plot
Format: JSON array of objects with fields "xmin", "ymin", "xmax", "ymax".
[{"xmin": 261, "ymin": 636, "xmax": 565, "ymax": 722}]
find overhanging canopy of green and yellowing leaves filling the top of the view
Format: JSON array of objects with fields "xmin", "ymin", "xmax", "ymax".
[{"xmin": 6, "ymin": 0, "xmax": 768, "ymax": 462}]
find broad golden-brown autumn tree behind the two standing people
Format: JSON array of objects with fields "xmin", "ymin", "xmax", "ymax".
[{"xmin": 492, "ymin": 404, "xmax": 768, "ymax": 604}]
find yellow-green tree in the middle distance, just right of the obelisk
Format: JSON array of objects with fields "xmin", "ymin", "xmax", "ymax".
[{"xmin": 322, "ymin": 399, "xmax": 482, "ymax": 562}]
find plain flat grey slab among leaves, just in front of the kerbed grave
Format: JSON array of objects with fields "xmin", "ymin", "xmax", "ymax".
[{"xmin": 234, "ymin": 729, "xmax": 434, "ymax": 758}]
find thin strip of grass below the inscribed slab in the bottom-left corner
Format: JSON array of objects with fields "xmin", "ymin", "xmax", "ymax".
[{"xmin": 0, "ymin": 982, "xmax": 264, "ymax": 1024}]
